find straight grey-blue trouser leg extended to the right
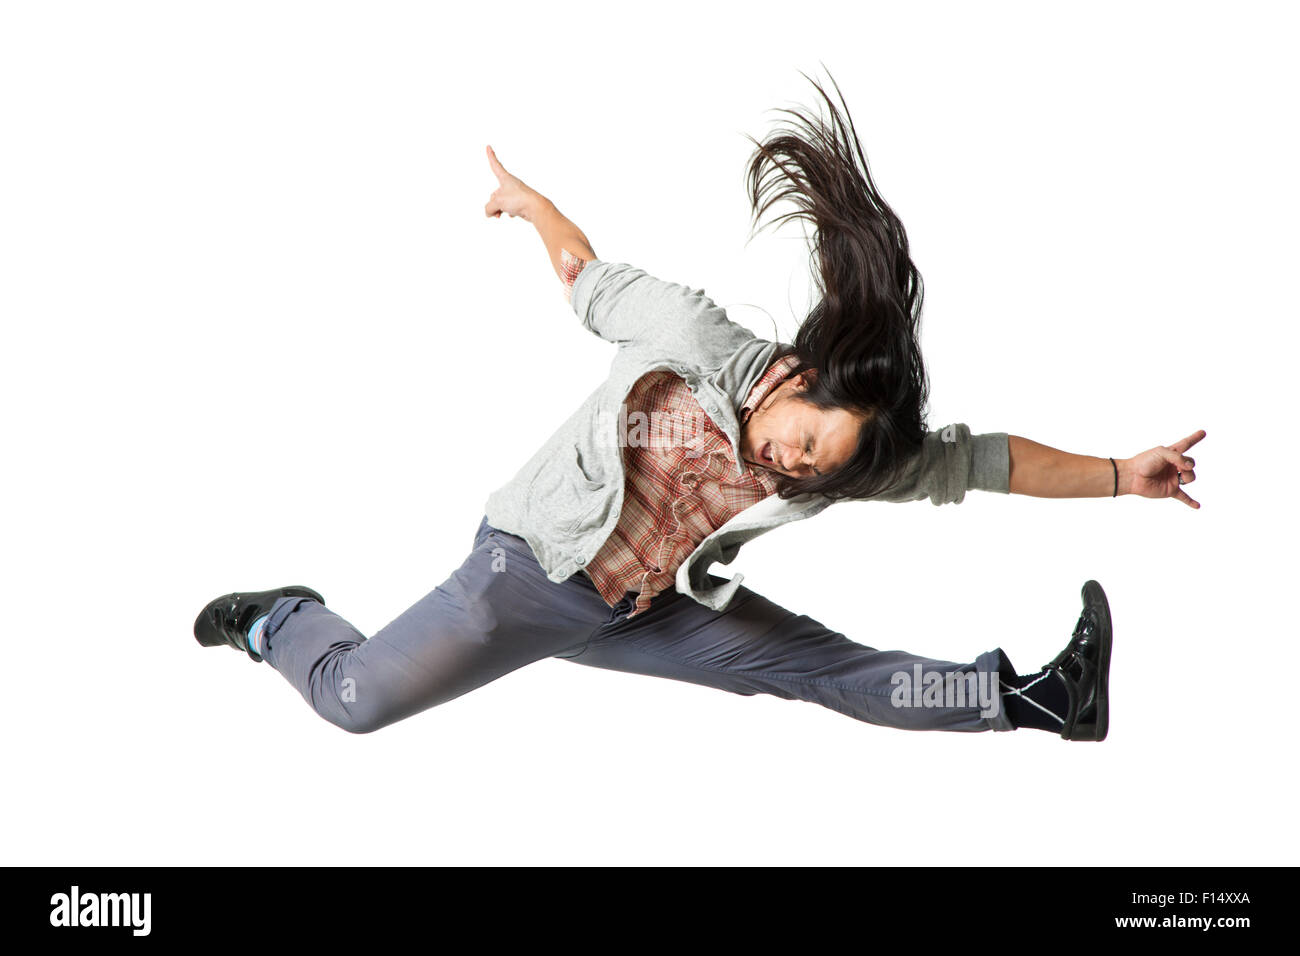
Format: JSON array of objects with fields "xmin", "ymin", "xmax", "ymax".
[{"xmin": 559, "ymin": 580, "xmax": 1014, "ymax": 731}]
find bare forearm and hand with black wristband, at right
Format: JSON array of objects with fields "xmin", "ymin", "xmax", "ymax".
[{"xmin": 1008, "ymin": 431, "xmax": 1205, "ymax": 509}]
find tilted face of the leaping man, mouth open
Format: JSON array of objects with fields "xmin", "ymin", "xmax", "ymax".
[{"xmin": 740, "ymin": 372, "xmax": 866, "ymax": 477}]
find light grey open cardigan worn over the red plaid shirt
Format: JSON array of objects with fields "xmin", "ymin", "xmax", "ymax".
[{"xmin": 486, "ymin": 260, "xmax": 1010, "ymax": 610}]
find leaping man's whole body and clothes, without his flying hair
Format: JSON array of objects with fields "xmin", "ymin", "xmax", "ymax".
[{"xmin": 195, "ymin": 147, "xmax": 1205, "ymax": 740}]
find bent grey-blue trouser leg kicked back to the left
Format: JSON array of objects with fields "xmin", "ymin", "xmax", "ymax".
[{"xmin": 263, "ymin": 519, "xmax": 611, "ymax": 734}]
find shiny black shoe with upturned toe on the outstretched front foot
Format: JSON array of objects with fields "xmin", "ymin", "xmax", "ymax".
[{"xmin": 1047, "ymin": 581, "xmax": 1110, "ymax": 740}]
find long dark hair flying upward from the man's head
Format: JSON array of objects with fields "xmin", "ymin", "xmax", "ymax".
[{"xmin": 746, "ymin": 72, "xmax": 930, "ymax": 499}]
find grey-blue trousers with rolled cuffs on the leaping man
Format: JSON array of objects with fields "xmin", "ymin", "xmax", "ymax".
[{"xmin": 263, "ymin": 518, "xmax": 1014, "ymax": 734}]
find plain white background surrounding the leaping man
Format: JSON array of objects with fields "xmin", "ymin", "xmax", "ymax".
[{"xmin": 0, "ymin": 0, "xmax": 1300, "ymax": 865}]
